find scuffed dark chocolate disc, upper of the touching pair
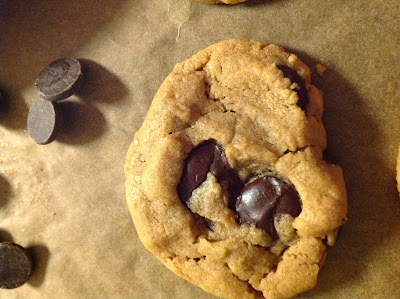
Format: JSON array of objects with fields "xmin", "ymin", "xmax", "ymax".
[{"xmin": 35, "ymin": 58, "xmax": 83, "ymax": 101}]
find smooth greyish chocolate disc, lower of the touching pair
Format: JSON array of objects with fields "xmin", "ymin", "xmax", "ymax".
[{"xmin": 27, "ymin": 99, "xmax": 63, "ymax": 145}]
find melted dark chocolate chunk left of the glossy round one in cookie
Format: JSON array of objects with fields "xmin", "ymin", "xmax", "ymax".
[{"xmin": 177, "ymin": 139, "xmax": 243, "ymax": 209}]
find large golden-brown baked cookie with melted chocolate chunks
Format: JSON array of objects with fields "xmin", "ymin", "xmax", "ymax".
[{"xmin": 125, "ymin": 39, "xmax": 347, "ymax": 298}]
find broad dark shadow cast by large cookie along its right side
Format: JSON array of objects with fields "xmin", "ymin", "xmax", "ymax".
[{"xmin": 288, "ymin": 49, "xmax": 400, "ymax": 298}]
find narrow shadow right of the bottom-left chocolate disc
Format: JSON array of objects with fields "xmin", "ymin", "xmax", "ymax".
[{"xmin": 26, "ymin": 244, "xmax": 50, "ymax": 287}]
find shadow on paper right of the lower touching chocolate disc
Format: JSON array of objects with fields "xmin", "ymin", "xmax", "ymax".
[{"xmin": 57, "ymin": 98, "xmax": 107, "ymax": 144}]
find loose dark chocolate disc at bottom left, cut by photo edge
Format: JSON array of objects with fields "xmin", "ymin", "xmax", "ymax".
[{"xmin": 0, "ymin": 242, "xmax": 32, "ymax": 289}]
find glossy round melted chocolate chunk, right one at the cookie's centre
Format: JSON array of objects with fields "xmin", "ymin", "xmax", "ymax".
[{"xmin": 236, "ymin": 176, "xmax": 301, "ymax": 235}]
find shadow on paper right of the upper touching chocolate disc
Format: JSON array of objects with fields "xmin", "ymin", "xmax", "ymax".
[{"xmin": 76, "ymin": 59, "xmax": 128, "ymax": 104}]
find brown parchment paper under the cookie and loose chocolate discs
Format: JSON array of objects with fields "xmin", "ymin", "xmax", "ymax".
[{"xmin": 0, "ymin": 0, "xmax": 400, "ymax": 298}]
